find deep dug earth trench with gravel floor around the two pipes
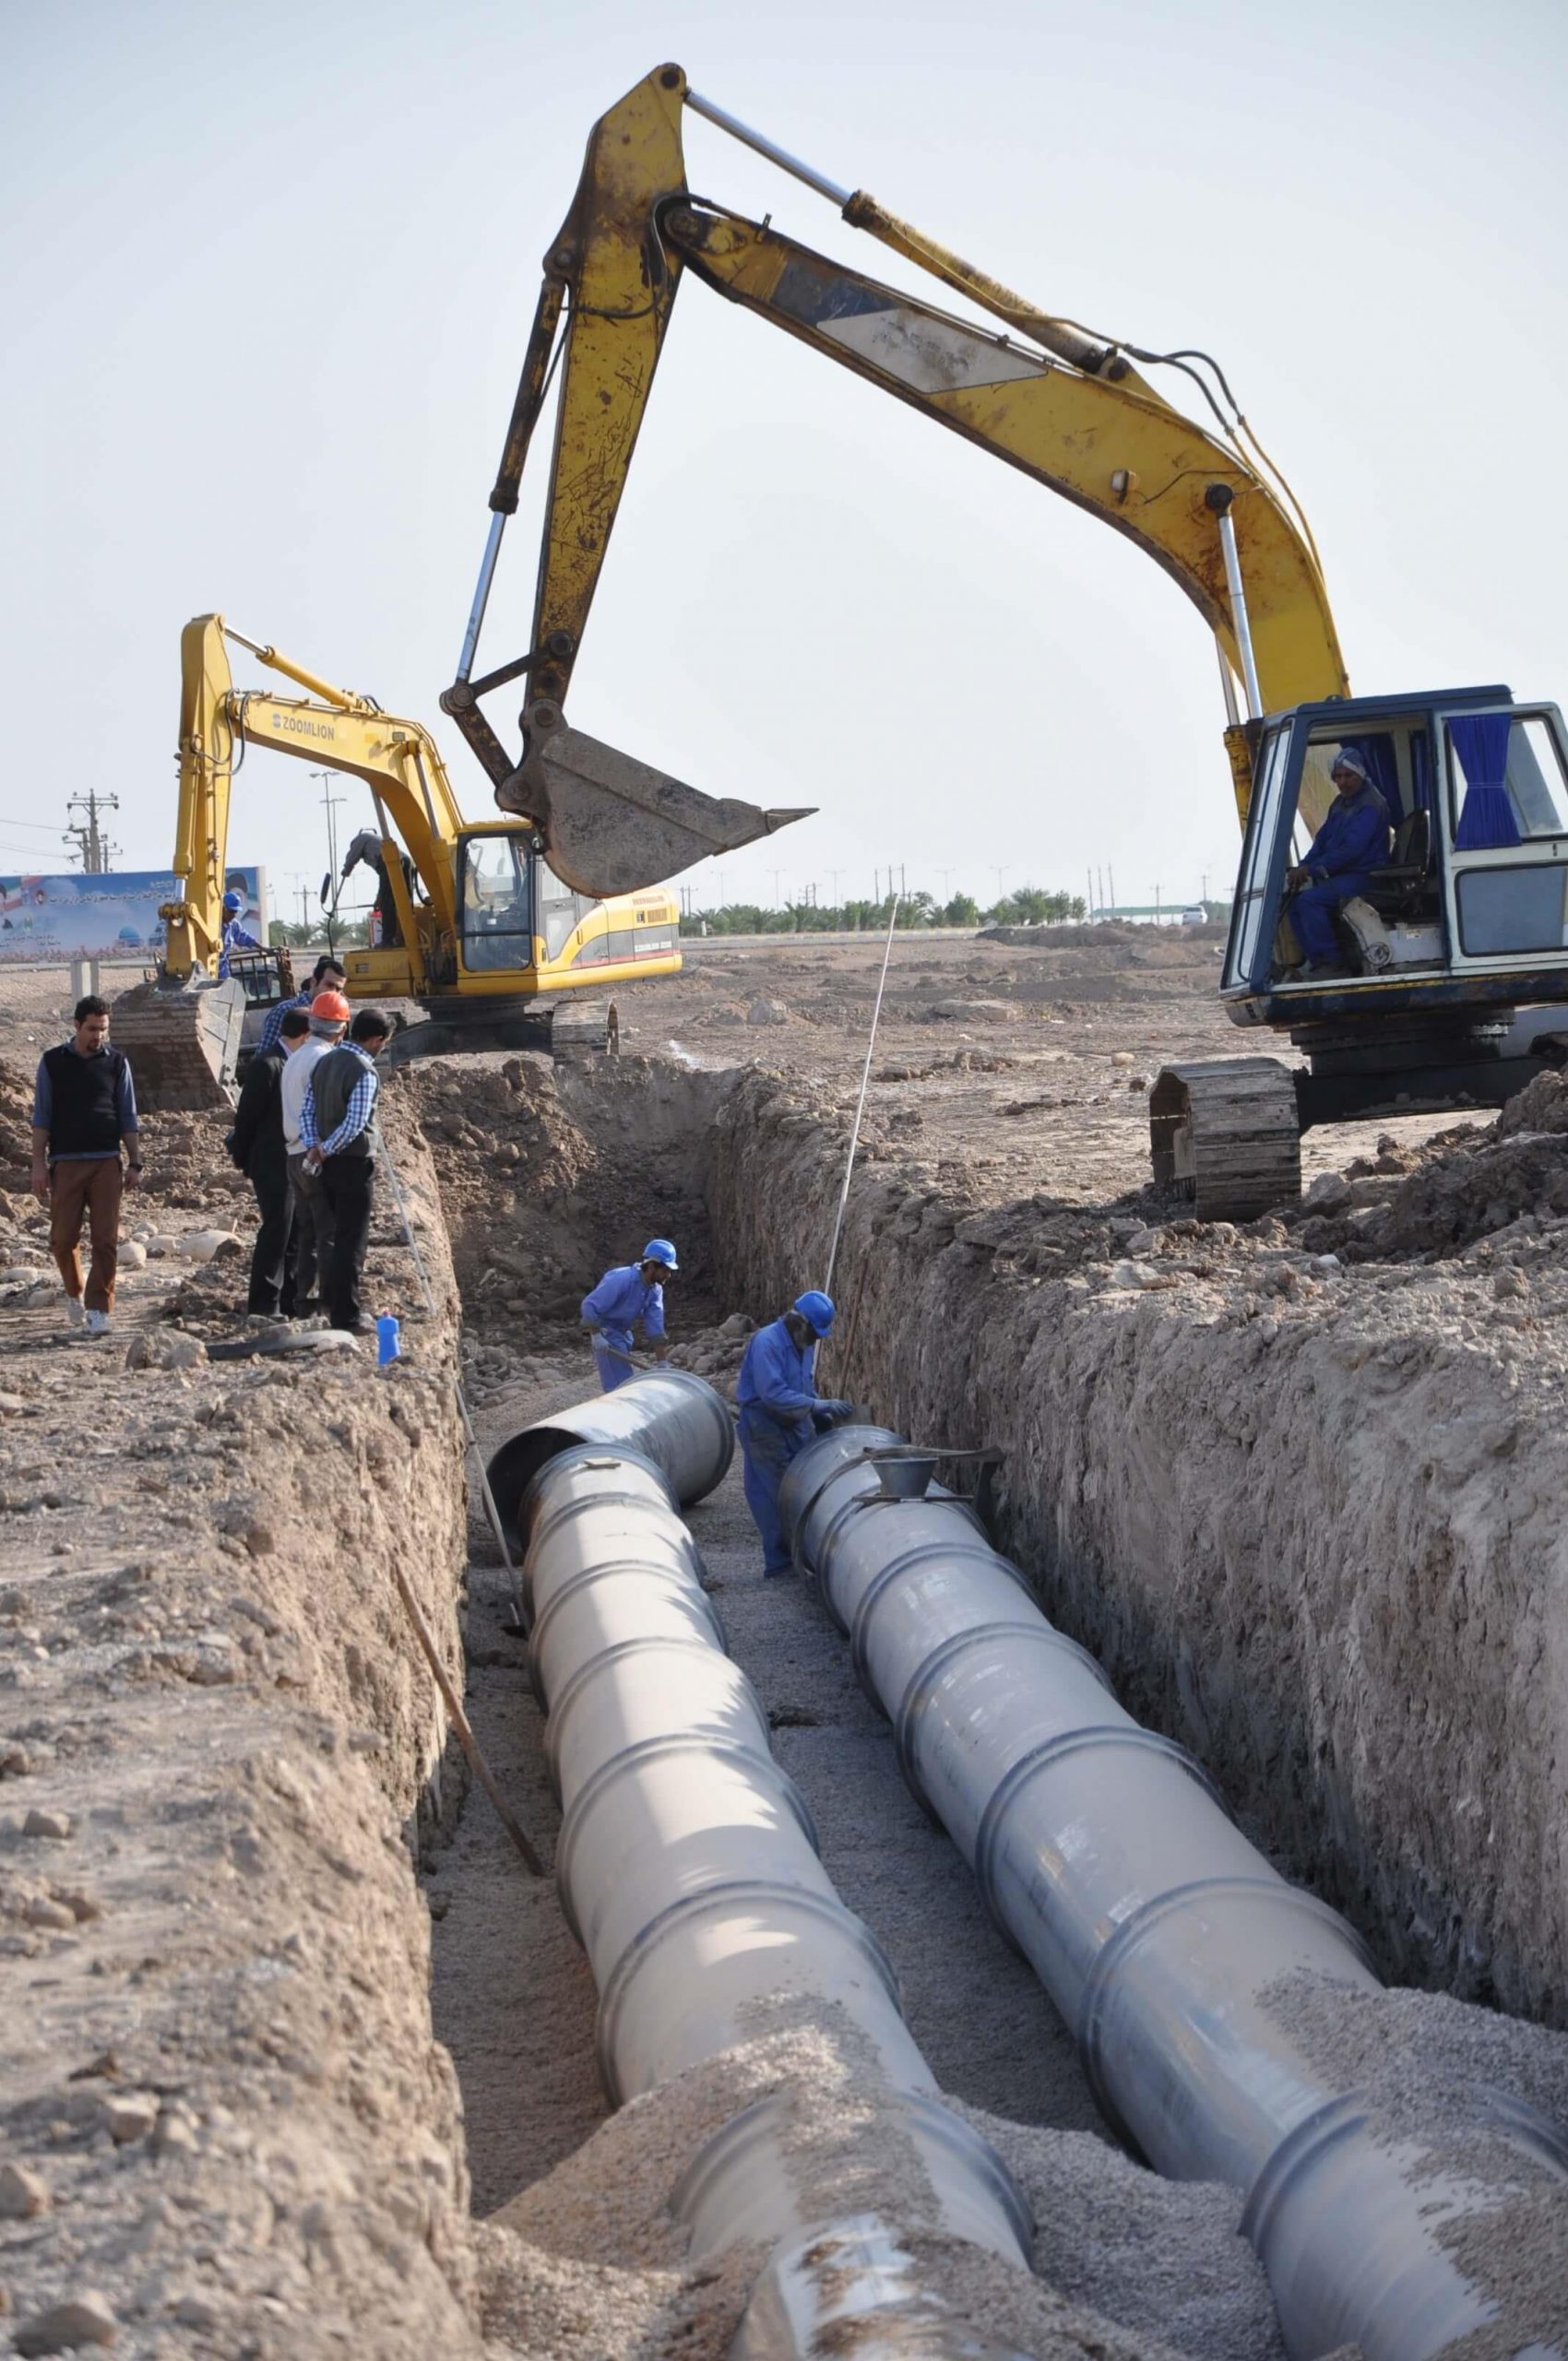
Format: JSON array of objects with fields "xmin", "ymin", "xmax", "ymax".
[{"xmin": 421, "ymin": 1060, "xmax": 1568, "ymax": 2361}]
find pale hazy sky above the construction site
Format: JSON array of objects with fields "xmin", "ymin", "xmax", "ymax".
[{"xmin": 0, "ymin": 0, "xmax": 1568, "ymax": 920}]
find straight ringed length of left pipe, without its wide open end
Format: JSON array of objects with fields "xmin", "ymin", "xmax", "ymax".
[{"xmin": 515, "ymin": 1417, "xmax": 1032, "ymax": 2361}]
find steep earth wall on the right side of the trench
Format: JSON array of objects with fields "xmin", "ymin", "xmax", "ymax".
[{"xmin": 708, "ymin": 1074, "xmax": 1568, "ymax": 2023}]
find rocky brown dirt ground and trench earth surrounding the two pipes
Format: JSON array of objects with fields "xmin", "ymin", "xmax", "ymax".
[{"xmin": 0, "ymin": 928, "xmax": 1568, "ymax": 2361}]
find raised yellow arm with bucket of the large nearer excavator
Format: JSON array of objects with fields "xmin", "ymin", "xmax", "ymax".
[{"xmin": 442, "ymin": 66, "xmax": 1348, "ymax": 893}]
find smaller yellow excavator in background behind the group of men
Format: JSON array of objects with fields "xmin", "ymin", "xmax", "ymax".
[{"xmin": 113, "ymin": 614, "xmax": 680, "ymax": 1108}]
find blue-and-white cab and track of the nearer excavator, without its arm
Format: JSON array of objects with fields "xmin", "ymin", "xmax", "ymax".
[{"xmin": 1150, "ymin": 687, "xmax": 1568, "ymax": 1218}]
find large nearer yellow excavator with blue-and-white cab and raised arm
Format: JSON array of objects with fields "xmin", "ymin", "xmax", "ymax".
[{"xmin": 442, "ymin": 66, "xmax": 1568, "ymax": 1218}]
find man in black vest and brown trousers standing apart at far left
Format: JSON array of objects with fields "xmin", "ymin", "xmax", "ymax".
[{"xmin": 33, "ymin": 991, "xmax": 142, "ymax": 1336}]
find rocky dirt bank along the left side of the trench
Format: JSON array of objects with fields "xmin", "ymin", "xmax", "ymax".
[{"xmin": 0, "ymin": 1091, "xmax": 480, "ymax": 2361}]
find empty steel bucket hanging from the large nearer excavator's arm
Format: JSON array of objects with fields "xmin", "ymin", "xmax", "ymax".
[{"xmin": 496, "ymin": 706, "xmax": 814, "ymax": 902}]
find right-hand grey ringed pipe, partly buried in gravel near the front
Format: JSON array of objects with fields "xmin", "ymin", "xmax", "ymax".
[{"xmin": 784, "ymin": 1426, "xmax": 1568, "ymax": 2361}]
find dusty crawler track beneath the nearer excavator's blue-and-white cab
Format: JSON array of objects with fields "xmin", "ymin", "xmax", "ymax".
[{"xmin": 1147, "ymin": 1058, "xmax": 1301, "ymax": 1221}]
